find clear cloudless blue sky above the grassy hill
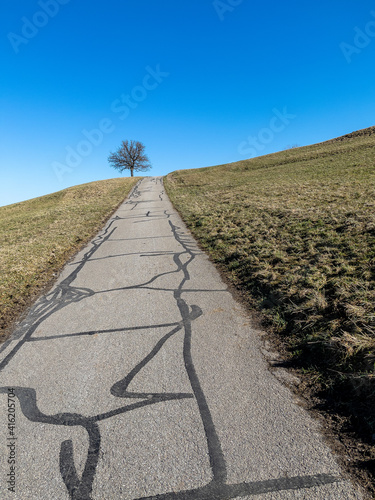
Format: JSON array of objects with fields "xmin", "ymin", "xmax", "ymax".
[{"xmin": 0, "ymin": 0, "xmax": 375, "ymax": 206}]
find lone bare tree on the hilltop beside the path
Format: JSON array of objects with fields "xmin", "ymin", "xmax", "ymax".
[{"xmin": 108, "ymin": 141, "xmax": 151, "ymax": 177}]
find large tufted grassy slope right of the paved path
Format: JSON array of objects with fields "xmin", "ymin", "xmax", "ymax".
[{"xmin": 165, "ymin": 127, "xmax": 375, "ymax": 446}]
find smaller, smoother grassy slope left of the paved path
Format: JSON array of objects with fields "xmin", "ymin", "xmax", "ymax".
[{"xmin": 0, "ymin": 178, "xmax": 138, "ymax": 340}]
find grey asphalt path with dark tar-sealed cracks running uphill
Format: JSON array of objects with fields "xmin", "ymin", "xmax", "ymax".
[{"xmin": 0, "ymin": 178, "xmax": 361, "ymax": 500}]
